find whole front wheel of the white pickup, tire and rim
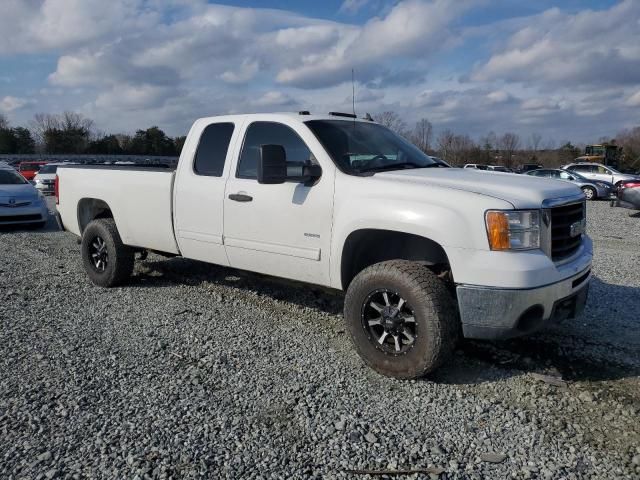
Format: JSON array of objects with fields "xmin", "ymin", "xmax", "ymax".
[{"xmin": 344, "ymin": 260, "xmax": 458, "ymax": 379}]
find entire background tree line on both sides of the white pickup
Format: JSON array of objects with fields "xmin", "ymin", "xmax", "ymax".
[{"xmin": 0, "ymin": 111, "xmax": 640, "ymax": 168}]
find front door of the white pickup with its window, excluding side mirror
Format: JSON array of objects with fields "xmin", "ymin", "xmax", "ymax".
[{"xmin": 224, "ymin": 121, "xmax": 335, "ymax": 285}]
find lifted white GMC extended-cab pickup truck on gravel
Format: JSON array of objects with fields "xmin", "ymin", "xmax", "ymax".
[{"xmin": 56, "ymin": 112, "xmax": 592, "ymax": 378}]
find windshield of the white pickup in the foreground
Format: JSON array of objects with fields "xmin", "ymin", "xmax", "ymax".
[{"xmin": 305, "ymin": 120, "xmax": 442, "ymax": 175}]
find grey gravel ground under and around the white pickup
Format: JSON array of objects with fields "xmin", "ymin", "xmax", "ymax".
[{"xmin": 0, "ymin": 197, "xmax": 640, "ymax": 479}]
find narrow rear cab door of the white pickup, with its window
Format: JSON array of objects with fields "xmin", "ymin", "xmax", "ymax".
[{"xmin": 174, "ymin": 117, "xmax": 240, "ymax": 265}]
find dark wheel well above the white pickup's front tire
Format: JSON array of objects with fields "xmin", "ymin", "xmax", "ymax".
[{"xmin": 340, "ymin": 229, "xmax": 449, "ymax": 290}]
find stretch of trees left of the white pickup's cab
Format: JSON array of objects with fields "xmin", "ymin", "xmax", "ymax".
[{"xmin": 0, "ymin": 112, "xmax": 186, "ymax": 156}]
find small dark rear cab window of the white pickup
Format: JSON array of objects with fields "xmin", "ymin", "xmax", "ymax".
[{"xmin": 193, "ymin": 123, "xmax": 238, "ymax": 177}]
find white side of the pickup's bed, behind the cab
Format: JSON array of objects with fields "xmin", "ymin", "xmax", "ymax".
[{"xmin": 58, "ymin": 165, "xmax": 179, "ymax": 254}]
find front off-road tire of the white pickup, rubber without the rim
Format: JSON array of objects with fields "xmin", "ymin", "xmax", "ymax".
[{"xmin": 344, "ymin": 260, "xmax": 459, "ymax": 379}]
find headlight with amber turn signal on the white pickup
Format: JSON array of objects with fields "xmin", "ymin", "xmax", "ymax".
[{"xmin": 485, "ymin": 210, "xmax": 540, "ymax": 250}]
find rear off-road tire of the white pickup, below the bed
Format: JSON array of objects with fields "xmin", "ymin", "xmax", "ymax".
[{"xmin": 80, "ymin": 218, "xmax": 134, "ymax": 287}]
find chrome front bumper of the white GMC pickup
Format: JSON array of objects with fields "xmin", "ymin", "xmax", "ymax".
[{"xmin": 456, "ymin": 265, "xmax": 591, "ymax": 339}]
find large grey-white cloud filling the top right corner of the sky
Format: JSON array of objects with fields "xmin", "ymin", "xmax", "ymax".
[{"xmin": 473, "ymin": 0, "xmax": 640, "ymax": 89}]
